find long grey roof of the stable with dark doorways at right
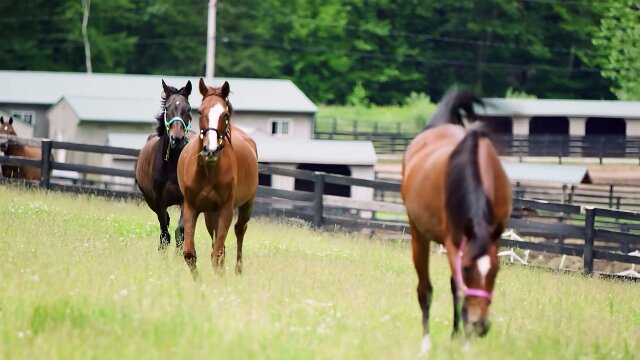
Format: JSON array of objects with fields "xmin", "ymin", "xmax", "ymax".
[{"xmin": 476, "ymin": 98, "xmax": 640, "ymax": 119}]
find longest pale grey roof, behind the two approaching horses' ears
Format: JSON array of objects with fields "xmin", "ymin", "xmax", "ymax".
[{"xmin": 0, "ymin": 70, "xmax": 318, "ymax": 114}]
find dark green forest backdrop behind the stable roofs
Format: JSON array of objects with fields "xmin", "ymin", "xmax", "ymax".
[{"xmin": 0, "ymin": 0, "xmax": 620, "ymax": 105}]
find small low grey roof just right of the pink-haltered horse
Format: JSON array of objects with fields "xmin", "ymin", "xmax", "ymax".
[{"xmin": 502, "ymin": 161, "xmax": 591, "ymax": 185}]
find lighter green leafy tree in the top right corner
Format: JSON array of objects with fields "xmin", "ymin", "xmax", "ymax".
[{"xmin": 593, "ymin": 0, "xmax": 640, "ymax": 100}]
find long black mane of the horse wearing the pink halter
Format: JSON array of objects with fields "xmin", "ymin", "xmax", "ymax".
[{"xmin": 445, "ymin": 123, "xmax": 493, "ymax": 259}]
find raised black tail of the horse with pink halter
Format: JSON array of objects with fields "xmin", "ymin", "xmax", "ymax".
[{"xmin": 427, "ymin": 88, "xmax": 484, "ymax": 128}]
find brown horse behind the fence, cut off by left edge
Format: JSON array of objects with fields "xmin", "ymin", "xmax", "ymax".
[{"xmin": 0, "ymin": 117, "xmax": 42, "ymax": 180}]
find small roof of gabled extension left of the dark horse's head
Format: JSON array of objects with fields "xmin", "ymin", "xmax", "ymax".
[{"xmin": 60, "ymin": 96, "xmax": 160, "ymax": 123}]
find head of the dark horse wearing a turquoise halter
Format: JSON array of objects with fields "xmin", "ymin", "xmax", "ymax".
[{"xmin": 156, "ymin": 80, "xmax": 191, "ymax": 149}]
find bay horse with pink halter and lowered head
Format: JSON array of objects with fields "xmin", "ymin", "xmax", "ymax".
[{"xmin": 401, "ymin": 90, "xmax": 511, "ymax": 352}]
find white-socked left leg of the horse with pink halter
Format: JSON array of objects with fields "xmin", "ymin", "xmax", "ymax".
[{"xmin": 409, "ymin": 223, "xmax": 433, "ymax": 354}]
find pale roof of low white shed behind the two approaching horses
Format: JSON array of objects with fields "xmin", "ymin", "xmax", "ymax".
[{"xmin": 107, "ymin": 133, "xmax": 377, "ymax": 166}]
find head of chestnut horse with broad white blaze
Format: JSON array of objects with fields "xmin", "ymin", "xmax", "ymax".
[{"xmin": 200, "ymin": 78, "xmax": 233, "ymax": 162}]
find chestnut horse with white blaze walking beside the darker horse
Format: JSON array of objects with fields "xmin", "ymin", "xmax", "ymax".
[{"xmin": 178, "ymin": 79, "xmax": 258, "ymax": 279}]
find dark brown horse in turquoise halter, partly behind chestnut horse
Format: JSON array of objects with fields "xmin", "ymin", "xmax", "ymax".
[{"xmin": 136, "ymin": 80, "xmax": 191, "ymax": 249}]
